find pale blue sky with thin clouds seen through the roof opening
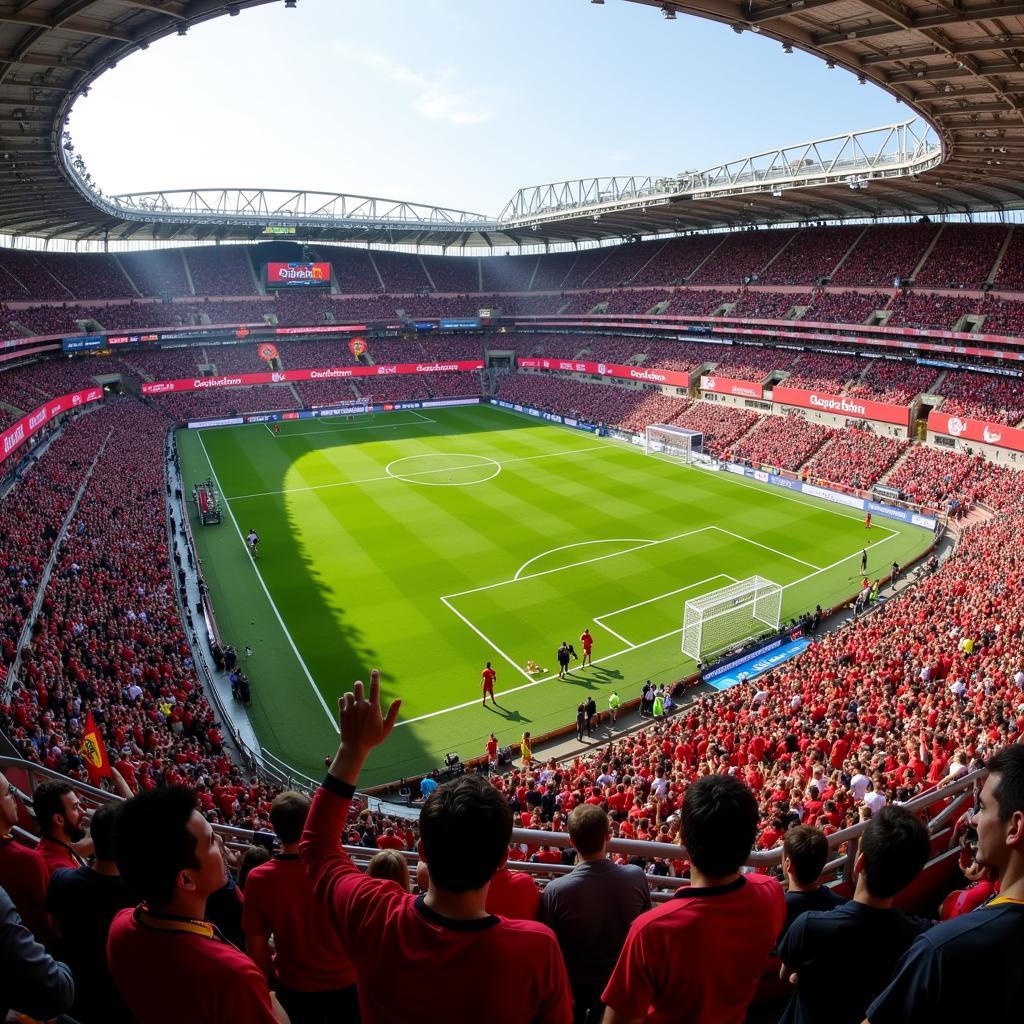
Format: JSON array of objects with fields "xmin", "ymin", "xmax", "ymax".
[{"xmin": 71, "ymin": 0, "xmax": 908, "ymax": 214}]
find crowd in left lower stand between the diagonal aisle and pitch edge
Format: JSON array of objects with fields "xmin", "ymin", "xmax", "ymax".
[{"xmin": 0, "ymin": 398, "xmax": 282, "ymax": 827}]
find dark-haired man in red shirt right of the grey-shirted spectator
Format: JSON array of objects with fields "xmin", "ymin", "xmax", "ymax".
[{"xmin": 601, "ymin": 775, "xmax": 785, "ymax": 1024}]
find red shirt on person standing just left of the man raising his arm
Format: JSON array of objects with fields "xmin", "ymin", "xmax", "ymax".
[{"xmin": 242, "ymin": 853, "xmax": 355, "ymax": 992}]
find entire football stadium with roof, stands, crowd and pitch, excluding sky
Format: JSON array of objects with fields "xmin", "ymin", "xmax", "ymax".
[{"xmin": 0, "ymin": 0, "xmax": 1024, "ymax": 1024}]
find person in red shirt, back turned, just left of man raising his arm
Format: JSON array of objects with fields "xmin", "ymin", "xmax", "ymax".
[{"xmin": 242, "ymin": 793, "xmax": 360, "ymax": 1024}]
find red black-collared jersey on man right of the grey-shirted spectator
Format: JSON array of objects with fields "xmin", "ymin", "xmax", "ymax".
[{"xmin": 601, "ymin": 874, "xmax": 785, "ymax": 1024}]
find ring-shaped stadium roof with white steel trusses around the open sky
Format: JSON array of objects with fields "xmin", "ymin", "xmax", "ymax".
[{"xmin": 0, "ymin": 0, "xmax": 1024, "ymax": 247}]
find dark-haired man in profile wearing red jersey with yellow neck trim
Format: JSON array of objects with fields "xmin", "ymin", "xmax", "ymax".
[{"xmin": 106, "ymin": 786, "xmax": 288, "ymax": 1024}]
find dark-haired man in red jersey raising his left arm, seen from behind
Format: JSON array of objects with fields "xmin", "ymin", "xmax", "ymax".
[{"xmin": 300, "ymin": 670, "xmax": 572, "ymax": 1024}]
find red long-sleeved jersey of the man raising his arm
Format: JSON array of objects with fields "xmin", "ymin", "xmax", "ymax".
[{"xmin": 299, "ymin": 776, "xmax": 572, "ymax": 1024}]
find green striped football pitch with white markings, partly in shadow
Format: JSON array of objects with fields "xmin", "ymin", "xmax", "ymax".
[{"xmin": 178, "ymin": 406, "xmax": 930, "ymax": 785}]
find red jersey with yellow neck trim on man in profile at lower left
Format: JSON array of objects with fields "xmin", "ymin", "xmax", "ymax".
[{"xmin": 106, "ymin": 907, "xmax": 278, "ymax": 1024}]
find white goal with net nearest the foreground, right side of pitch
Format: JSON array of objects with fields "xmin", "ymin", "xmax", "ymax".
[{"xmin": 682, "ymin": 577, "xmax": 782, "ymax": 660}]
